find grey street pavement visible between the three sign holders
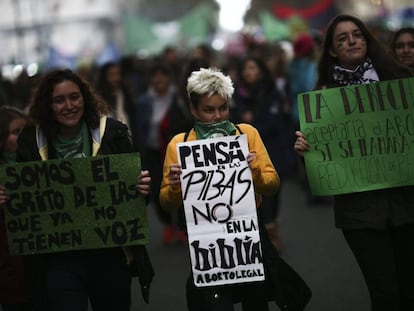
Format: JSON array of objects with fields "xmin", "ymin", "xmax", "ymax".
[{"xmin": 131, "ymin": 180, "xmax": 370, "ymax": 311}]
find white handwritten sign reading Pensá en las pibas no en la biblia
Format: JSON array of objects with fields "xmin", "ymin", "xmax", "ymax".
[{"xmin": 177, "ymin": 135, "xmax": 264, "ymax": 287}]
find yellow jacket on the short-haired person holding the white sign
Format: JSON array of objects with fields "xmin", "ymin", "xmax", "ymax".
[{"xmin": 160, "ymin": 124, "xmax": 280, "ymax": 209}]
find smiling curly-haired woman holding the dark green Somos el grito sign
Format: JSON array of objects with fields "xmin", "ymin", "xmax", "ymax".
[{"xmin": 0, "ymin": 69, "xmax": 153, "ymax": 311}]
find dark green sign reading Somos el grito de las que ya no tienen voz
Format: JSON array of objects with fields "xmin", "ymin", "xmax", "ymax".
[{"xmin": 0, "ymin": 153, "xmax": 148, "ymax": 255}]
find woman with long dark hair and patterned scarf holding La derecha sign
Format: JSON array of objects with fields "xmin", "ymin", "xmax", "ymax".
[{"xmin": 294, "ymin": 15, "xmax": 414, "ymax": 311}]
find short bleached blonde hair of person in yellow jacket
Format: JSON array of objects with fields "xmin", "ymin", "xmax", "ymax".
[{"xmin": 187, "ymin": 68, "xmax": 234, "ymax": 100}]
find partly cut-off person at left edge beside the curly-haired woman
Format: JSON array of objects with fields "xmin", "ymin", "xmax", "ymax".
[{"xmin": 0, "ymin": 106, "xmax": 31, "ymax": 311}]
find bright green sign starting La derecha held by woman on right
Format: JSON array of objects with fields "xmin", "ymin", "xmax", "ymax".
[{"xmin": 298, "ymin": 78, "xmax": 414, "ymax": 195}]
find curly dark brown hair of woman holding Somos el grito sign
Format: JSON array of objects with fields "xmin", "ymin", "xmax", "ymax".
[{"xmin": 29, "ymin": 69, "xmax": 108, "ymax": 138}]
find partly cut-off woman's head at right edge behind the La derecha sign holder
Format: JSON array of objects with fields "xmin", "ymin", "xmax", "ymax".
[{"xmin": 391, "ymin": 27, "xmax": 414, "ymax": 70}]
